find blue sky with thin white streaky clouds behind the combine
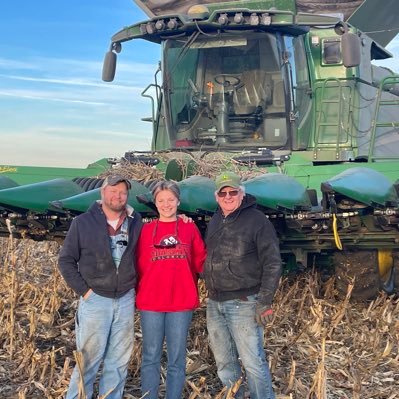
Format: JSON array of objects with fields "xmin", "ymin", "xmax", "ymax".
[{"xmin": 0, "ymin": 0, "xmax": 399, "ymax": 167}]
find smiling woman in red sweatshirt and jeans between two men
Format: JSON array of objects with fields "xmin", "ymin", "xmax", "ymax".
[{"xmin": 136, "ymin": 181, "xmax": 206, "ymax": 399}]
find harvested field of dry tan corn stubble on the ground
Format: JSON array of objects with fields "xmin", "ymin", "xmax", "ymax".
[{"xmin": 0, "ymin": 238, "xmax": 399, "ymax": 399}]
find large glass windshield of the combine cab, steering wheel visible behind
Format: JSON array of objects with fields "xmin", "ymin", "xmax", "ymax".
[{"xmin": 164, "ymin": 32, "xmax": 289, "ymax": 148}]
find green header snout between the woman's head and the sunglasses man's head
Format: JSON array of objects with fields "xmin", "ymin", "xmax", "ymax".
[{"xmin": 178, "ymin": 176, "xmax": 217, "ymax": 213}]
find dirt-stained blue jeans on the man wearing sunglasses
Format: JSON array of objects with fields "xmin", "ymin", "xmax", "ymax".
[{"xmin": 206, "ymin": 295, "xmax": 275, "ymax": 399}]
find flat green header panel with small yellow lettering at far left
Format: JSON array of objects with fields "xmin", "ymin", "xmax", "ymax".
[{"xmin": 0, "ymin": 158, "xmax": 111, "ymax": 185}]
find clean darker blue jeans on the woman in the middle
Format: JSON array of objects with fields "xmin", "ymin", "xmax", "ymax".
[{"xmin": 140, "ymin": 311, "xmax": 193, "ymax": 399}]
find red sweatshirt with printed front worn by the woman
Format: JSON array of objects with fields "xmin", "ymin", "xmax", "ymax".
[{"xmin": 136, "ymin": 218, "xmax": 206, "ymax": 312}]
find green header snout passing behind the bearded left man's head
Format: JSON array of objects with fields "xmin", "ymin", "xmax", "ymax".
[{"xmin": 50, "ymin": 180, "xmax": 149, "ymax": 213}]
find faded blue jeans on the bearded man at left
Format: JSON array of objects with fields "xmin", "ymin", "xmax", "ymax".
[{"xmin": 66, "ymin": 289, "xmax": 135, "ymax": 399}]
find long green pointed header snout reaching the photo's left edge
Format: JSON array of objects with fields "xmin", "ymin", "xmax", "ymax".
[{"xmin": 0, "ymin": 178, "xmax": 83, "ymax": 212}]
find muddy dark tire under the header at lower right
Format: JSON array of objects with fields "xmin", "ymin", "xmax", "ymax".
[{"xmin": 333, "ymin": 250, "xmax": 380, "ymax": 301}]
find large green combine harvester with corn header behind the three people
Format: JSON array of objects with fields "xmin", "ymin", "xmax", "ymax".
[{"xmin": 0, "ymin": 0, "xmax": 399, "ymax": 299}]
